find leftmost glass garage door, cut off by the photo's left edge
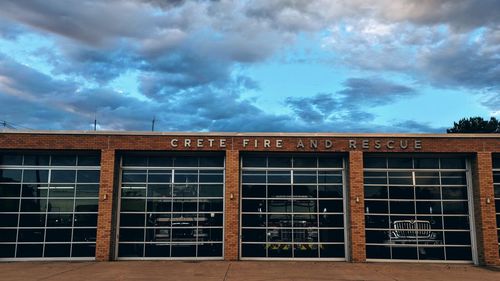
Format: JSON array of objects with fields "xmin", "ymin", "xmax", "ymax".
[{"xmin": 0, "ymin": 153, "xmax": 100, "ymax": 260}]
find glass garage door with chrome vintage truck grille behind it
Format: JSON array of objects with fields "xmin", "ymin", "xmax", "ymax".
[{"xmin": 364, "ymin": 157, "xmax": 473, "ymax": 261}]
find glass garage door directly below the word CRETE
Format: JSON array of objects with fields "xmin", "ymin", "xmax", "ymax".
[{"xmin": 118, "ymin": 155, "xmax": 224, "ymax": 259}]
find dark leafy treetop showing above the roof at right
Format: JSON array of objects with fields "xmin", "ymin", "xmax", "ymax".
[{"xmin": 446, "ymin": 117, "xmax": 500, "ymax": 134}]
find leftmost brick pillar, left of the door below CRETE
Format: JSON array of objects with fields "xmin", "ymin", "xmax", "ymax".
[{"xmin": 96, "ymin": 149, "xmax": 115, "ymax": 261}]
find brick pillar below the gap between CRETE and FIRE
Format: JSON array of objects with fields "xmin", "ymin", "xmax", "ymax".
[{"xmin": 224, "ymin": 150, "xmax": 240, "ymax": 261}]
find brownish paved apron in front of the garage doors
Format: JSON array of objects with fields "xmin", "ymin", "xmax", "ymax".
[{"xmin": 0, "ymin": 261, "xmax": 500, "ymax": 281}]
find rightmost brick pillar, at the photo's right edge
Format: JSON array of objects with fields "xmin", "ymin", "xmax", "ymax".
[{"xmin": 472, "ymin": 152, "xmax": 500, "ymax": 265}]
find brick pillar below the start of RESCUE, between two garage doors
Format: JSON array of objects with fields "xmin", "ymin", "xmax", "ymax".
[{"xmin": 348, "ymin": 151, "xmax": 366, "ymax": 262}]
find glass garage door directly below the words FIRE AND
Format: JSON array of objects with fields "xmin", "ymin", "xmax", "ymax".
[{"xmin": 240, "ymin": 156, "xmax": 345, "ymax": 259}]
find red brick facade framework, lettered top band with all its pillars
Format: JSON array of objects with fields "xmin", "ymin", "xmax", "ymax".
[{"xmin": 0, "ymin": 133, "xmax": 500, "ymax": 264}]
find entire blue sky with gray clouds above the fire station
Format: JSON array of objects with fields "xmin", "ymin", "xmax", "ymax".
[{"xmin": 0, "ymin": 0, "xmax": 500, "ymax": 133}]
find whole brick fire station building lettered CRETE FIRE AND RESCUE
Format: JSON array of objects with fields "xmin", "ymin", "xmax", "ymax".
[{"xmin": 0, "ymin": 131, "xmax": 500, "ymax": 265}]
